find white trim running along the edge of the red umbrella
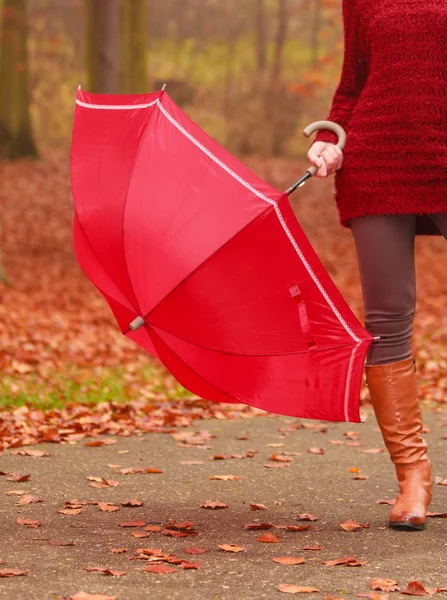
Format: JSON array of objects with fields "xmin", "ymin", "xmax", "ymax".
[{"xmin": 76, "ymin": 98, "xmax": 362, "ymax": 421}]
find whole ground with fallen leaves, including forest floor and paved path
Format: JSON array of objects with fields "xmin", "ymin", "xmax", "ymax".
[{"xmin": 0, "ymin": 155, "xmax": 447, "ymax": 600}]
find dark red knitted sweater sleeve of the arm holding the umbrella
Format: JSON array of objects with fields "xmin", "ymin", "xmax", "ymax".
[{"xmin": 312, "ymin": 0, "xmax": 368, "ymax": 144}]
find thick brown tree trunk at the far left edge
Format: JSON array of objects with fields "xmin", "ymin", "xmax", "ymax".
[{"xmin": 0, "ymin": 0, "xmax": 37, "ymax": 159}]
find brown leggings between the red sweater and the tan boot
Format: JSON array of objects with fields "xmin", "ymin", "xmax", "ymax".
[{"xmin": 350, "ymin": 213, "xmax": 447, "ymax": 365}]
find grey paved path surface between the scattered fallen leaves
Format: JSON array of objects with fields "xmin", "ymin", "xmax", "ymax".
[{"xmin": 0, "ymin": 409, "xmax": 447, "ymax": 600}]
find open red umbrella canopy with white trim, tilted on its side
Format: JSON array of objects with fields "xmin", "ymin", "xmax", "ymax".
[{"xmin": 71, "ymin": 91, "xmax": 372, "ymax": 422}]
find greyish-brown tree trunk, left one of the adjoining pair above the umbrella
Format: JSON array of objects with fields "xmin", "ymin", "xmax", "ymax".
[{"xmin": 85, "ymin": 0, "xmax": 120, "ymax": 94}]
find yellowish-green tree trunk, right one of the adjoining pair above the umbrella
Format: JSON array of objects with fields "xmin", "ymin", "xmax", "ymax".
[{"xmin": 120, "ymin": 0, "xmax": 148, "ymax": 94}]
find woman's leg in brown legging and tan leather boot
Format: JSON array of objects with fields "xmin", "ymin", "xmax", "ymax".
[{"xmin": 351, "ymin": 215, "xmax": 432, "ymax": 529}]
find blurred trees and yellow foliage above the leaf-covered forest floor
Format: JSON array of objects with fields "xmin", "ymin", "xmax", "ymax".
[{"xmin": 0, "ymin": 0, "xmax": 343, "ymax": 158}]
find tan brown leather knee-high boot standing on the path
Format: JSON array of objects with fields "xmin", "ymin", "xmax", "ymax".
[{"xmin": 365, "ymin": 358, "xmax": 432, "ymax": 530}]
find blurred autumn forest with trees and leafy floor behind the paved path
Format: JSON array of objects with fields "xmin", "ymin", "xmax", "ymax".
[{"xmin": 0, "ymin": 0, "xmax": 447, "ymax": 418}]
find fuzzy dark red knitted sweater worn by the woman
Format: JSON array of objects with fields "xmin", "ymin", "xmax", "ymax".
[{"xmin": 315, "ymin": 0, "xmax": 447, "ymax": 234}]
